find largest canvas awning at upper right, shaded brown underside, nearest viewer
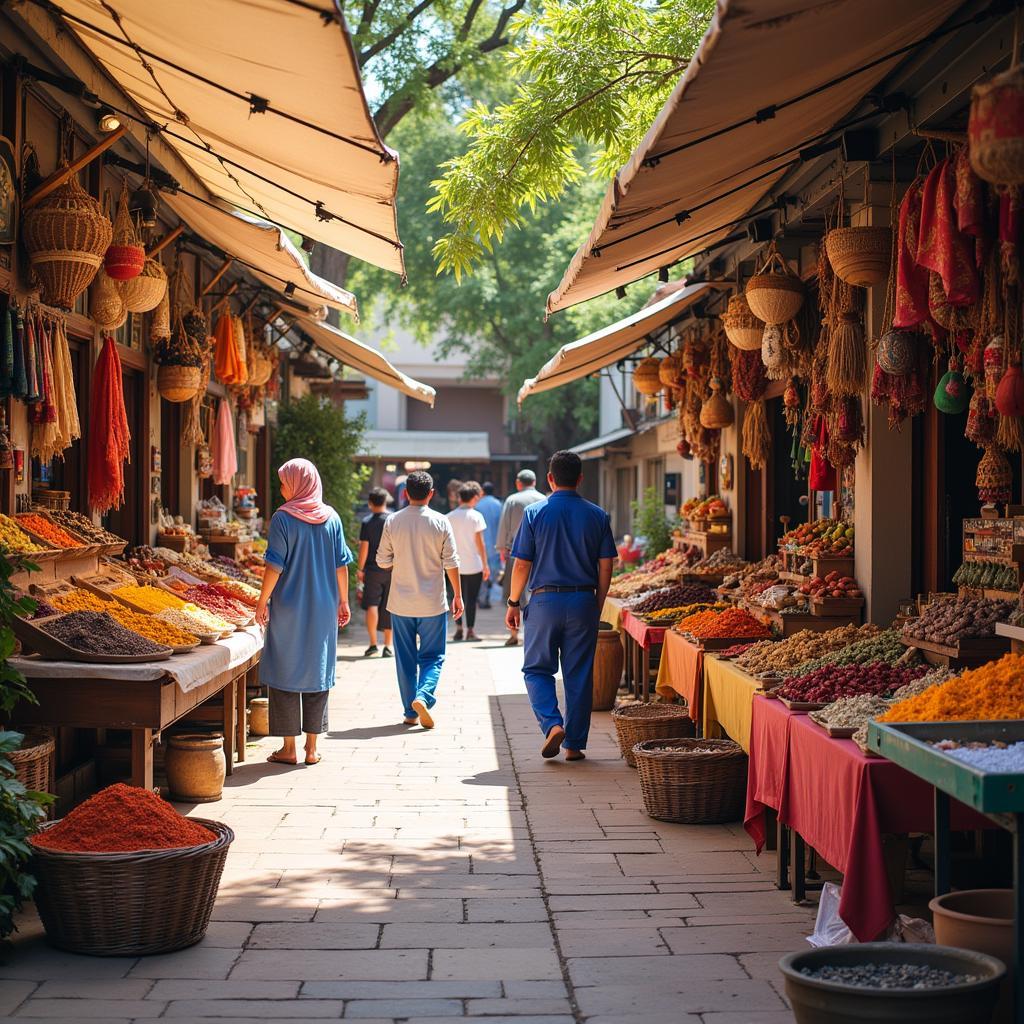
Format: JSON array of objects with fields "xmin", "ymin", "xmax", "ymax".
[{"xmin": 548, "ymin": 0, "xmax": 962, "ymax": 312}]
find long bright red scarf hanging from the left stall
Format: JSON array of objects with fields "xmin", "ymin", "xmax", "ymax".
[{"xmin": 89, "ymin": 335, "xmax": 131, "ymax": 514}]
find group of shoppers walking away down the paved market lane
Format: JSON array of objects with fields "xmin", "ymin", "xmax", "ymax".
[{"xmin": 256, "ymin": 452, "xmax": 615, "ymax": 764}]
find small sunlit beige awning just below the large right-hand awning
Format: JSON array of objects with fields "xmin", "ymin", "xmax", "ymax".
[{"xmin": 519, "ymin": 283, "xmax": 716, "ymax": 404}]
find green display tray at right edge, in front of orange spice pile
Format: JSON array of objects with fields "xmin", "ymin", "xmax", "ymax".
[{"xmin": 867, "ymin": 720, "xmax": 1024, "ymax": 814}]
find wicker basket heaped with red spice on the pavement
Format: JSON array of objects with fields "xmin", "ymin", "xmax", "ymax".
[{"xmin": 32, "ymin": 783, "xmax": 234, "ymax": 956}]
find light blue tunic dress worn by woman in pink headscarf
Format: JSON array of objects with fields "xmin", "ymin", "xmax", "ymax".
[{"xmin": 259, "ymin": 512, "xmax": 352, "ymax": 693}]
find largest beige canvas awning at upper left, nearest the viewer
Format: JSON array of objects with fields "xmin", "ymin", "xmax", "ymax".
[{"xmin": 47, "ymin": 0, "xmax": 404, "ymax": 273}]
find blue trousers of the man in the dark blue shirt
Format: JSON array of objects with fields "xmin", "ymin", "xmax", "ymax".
[{"xmin": 522, "ymin": 591, "xmax": 598, "ymax": 751}]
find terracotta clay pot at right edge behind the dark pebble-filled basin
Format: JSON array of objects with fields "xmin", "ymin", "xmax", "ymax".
[{"xmin": 928, "ymin": 889, "xmax": 1014, "ymax": 1024}]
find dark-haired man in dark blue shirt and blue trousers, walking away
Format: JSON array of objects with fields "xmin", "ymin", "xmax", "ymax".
[{"xmin": 505, "ymin": 452, "xmax": 616, "ymax": 761}]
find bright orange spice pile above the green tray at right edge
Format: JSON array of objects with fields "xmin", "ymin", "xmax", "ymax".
[{"xmin": 879, "ymin": 654, "xmax": 1024, "ymax": 722}]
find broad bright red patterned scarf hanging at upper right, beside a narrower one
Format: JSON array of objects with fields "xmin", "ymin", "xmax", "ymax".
[{"xmin": 917, "ymin": 159, "xmax": 981, "ymax": 305}]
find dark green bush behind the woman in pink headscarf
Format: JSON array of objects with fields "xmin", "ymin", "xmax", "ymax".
[{"xmin": 271, "ymin": 394, "xmax": 370, "ymax": 546}]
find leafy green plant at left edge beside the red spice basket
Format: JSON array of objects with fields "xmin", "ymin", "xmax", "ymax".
[{"xmin": 0, "ymin": 552, "xmax": 53, "ymax": 938}]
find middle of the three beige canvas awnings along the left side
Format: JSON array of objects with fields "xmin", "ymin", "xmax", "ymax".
[{"xmin": 162, "ymin": 193, "xmax": 358, "ymax": 316}]
